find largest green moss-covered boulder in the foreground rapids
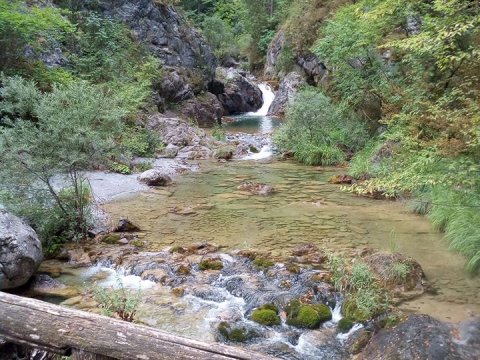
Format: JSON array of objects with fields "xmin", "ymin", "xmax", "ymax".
[{"xmin": 285, "ymin": 300, "xmax": 332, "ymax": 329}]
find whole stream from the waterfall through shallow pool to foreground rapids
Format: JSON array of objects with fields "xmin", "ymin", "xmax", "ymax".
[{"xmin": 43, "ymin": 83, "xmax": 480, "ymax": 359}]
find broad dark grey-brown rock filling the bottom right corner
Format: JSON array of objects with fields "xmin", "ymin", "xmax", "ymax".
[{"xmin": 359, "ymin": 315, "xmax": 480, "ymax": 360}]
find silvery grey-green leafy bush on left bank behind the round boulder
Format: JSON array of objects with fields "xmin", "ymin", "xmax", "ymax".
[{"xmin": 0, "ymin": 78, "xmax": 126, "ymax": 243}]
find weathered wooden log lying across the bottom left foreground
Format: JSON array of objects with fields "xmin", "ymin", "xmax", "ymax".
[{"xmin": 0, "ymin": 292, "xmax": 272, "ymax": 360}]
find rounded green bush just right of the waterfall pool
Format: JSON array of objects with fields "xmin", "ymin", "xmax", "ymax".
[{"xmin": 274, "ymin": 88, "xmax": 367, "ymax": 165}]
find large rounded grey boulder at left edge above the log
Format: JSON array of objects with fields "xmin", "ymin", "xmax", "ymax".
[{"xmin": 0, "ymin": 210, "xmax": 43, "ymax": 290}]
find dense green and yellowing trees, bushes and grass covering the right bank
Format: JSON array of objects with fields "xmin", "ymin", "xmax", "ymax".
[{"xmin": 272, "ymin": 0, "xmax": 480, "ymax": 272}]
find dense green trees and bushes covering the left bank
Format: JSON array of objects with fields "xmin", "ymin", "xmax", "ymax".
[{"xmin": 0, "ymin": 1, "xmax": 161, "ymax": 255}]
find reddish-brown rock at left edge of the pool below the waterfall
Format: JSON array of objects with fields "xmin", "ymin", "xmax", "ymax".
[{"xmin": 181, "ymin": 92, "xmax": 223, "ymax": 127}]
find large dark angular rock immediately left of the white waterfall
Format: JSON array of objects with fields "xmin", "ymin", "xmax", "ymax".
[{"xmin": 216, "ymin": 68, "xmax": 263, "ymax": 115}]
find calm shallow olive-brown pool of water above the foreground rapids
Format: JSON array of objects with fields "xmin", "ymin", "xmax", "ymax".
[{"xmin": 105, "ymin": 161, "xmax": 480, "ymax": 321}]
